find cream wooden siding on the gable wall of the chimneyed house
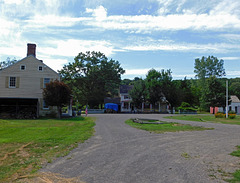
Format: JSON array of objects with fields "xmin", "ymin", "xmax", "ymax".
[{"xmin": 0, "ymin": 56, "xmax": 60, "ymax": 98}]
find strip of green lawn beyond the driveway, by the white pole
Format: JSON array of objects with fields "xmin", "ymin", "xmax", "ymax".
[{"xmin": 166, "ymin": 115, "xmax": 240, "ymax": 125}]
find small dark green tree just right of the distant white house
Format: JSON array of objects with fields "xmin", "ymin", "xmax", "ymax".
[{"xmin": 129, "ymin": 79, "xmax": 147, "ymax": 108}]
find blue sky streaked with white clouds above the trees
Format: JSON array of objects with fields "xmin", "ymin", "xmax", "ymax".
[{"xmin": 0, "ymin": 0, "xmax": 240, "ymax": 79}]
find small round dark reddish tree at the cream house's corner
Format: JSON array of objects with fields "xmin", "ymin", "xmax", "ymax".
[{"xmin": 43, "ymin": 80, "xmax": 71, "ymax": 118}]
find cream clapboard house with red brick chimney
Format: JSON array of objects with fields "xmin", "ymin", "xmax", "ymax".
[{"xmin": 0, "ymin": 44, "xmax": 60, "ymax": 118}]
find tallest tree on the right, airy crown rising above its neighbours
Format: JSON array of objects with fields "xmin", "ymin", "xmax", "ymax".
[{"xmin": 194, "ymin": 56, "xmax": 225, "ymax": 110}]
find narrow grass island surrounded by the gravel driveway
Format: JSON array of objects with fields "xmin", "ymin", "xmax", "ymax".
[{"xmin": 125, "ymin": 119, "xmax": 213, "ymax": 133}]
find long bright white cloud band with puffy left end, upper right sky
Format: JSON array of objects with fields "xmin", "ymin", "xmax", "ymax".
[{"xmin": 85, "ymin": 7, "xmax": 240, "ymax": 32}]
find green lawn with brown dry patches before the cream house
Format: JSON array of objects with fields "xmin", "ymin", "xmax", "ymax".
[{"xmin": 0, "ymin": 117, "xmax": 95, "ymax": 182}]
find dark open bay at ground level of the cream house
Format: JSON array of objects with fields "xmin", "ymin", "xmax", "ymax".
[{"xmin": 0, "ymin": 98, "xmax": 38, "ymax": 119}]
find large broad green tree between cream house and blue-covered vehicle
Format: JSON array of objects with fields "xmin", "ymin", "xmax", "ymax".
[{"xmin": 59, "ymin": 51, "xmax": 125, "ymax": 108}]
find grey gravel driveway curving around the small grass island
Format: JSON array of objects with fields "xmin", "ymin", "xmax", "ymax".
[{"xmin": 41, "ymin": 114, "xmax": 240, "ymax": 183}]
